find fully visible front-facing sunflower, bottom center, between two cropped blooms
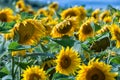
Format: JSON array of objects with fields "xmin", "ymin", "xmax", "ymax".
[{"xmin": 56, "ymin": 47, "xmax": 80, "ymax": 75}]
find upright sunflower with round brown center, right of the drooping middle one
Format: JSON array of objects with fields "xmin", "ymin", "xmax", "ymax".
[{"xmin": 78, "ymin": 21, "xmax": 94, "ymax": 41}]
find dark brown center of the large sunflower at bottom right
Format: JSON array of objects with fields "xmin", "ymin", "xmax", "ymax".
[{"xmin": 86, "ymin": 68, "xmax": 105, "ymax": 80}]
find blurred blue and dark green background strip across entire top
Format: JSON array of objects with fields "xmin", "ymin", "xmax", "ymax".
[{"xmin": 0, "ymin": 0, "xmax": 120, "ymax": 9}]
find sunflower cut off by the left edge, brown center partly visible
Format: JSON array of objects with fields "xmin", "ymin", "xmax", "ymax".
[{"xmin": 0, "ymin": 8, "xmax": 16, "ymax": 22}]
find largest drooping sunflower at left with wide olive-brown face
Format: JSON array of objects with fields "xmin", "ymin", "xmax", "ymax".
[{"xmin": 15, "ymin": 19, "xmax": 45, "ymax": 45}]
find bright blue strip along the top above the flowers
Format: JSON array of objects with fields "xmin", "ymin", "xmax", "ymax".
[{"xmin": 29, "ymin": 0, "xmax": 120, "ymax": 9}]
